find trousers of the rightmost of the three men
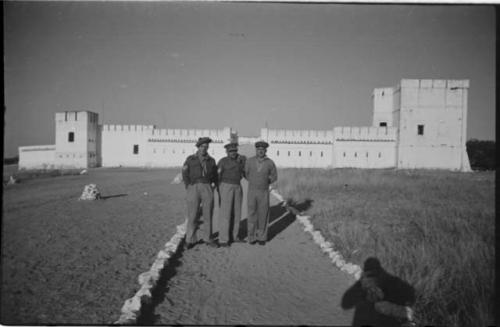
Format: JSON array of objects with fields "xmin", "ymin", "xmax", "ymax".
[{"xmin": 247, "ymin": 188, "xmax": 269, "ymax": 242}]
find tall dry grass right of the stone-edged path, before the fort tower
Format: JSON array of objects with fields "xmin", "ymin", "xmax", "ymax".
[{"xmin": 278, "ymin": 169, "xmax": 495, "ymax": 326}]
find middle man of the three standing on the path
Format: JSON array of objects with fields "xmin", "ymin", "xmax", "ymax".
[{"xmin": 217, "ymin": 143, "xmax": 246, "ymax": 247}]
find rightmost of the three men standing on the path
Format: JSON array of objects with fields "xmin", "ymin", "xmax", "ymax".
[{"xmin": 245, "ymin": 141, "xmax": 278, "ymax": 245}]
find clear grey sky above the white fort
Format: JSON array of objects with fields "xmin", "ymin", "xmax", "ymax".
[{"xmin": 3, "ymin": 1, "xmax": 495, "ymax": 157}]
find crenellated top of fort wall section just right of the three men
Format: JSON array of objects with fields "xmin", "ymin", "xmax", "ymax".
[{"xmin": 260, "ymin": 128, "xmax": 333, "ymax": 144}]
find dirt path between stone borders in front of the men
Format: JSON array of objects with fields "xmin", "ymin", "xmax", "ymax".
[{"xmin": 143, "ymin": 182, "xmax": 354, "ymax": 325}]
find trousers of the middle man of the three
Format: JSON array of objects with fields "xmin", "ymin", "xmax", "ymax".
[{"xmin": 219, "ymin": 183, "xmax": 243, "ymax": 243}]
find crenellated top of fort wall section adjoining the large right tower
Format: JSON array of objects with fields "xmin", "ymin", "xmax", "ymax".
[{"xmin": 333, "ymin": 127, "xmax": 398, "ymax": 142}]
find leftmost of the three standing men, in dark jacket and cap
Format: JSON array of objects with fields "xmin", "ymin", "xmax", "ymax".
[{"xmin": 182, "ymin": 137, "xmax": 217, "ymax": 249}]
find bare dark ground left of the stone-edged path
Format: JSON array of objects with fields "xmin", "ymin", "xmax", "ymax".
[{"xmin": 1, "ymin": 169, "xmax": 184, "ymax": 325}]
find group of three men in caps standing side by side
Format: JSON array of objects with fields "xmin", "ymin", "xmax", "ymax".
[{"xmin": 182, "ymin": 137, "xmax": 278, "ymax": 249}]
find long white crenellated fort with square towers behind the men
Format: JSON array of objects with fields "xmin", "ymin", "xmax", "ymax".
[{"xmin": 19, "ymin": 79, "xmax": 470, "ymax": 171}]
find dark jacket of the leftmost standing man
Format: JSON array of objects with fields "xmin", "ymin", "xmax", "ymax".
[{"xmin": 182, "ymin": 154, "xmax": 217, "ymax": 187}]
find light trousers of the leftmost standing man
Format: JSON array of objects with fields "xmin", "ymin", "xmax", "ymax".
[{"xmin": 186, "ymin": 183, "xmax": 214, "ymax": 244}]
